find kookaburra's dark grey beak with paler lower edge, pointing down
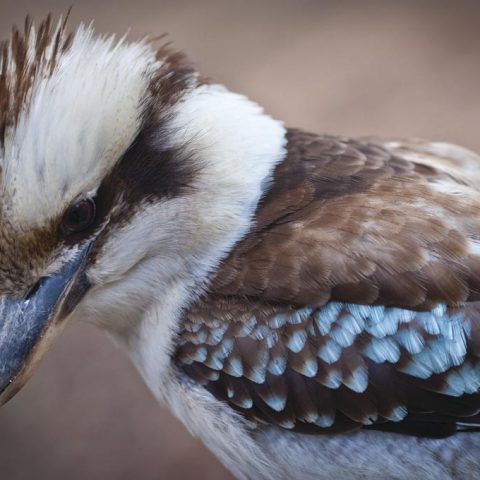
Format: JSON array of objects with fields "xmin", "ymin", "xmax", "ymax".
[{"xmin": 0, "ymin": 244, "xmax": 90, "ymax": 405}]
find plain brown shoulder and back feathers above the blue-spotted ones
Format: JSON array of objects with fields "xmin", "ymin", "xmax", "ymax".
[{"xmin": 212, "ymin": 130, "xmax": 480, "ymax": 309}]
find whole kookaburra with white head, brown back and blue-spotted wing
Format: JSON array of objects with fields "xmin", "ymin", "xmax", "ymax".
[{"xmin": 0, "ymin": 16, "xmax": 480, "ymax": 480}]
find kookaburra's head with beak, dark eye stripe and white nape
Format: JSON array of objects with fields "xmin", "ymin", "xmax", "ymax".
[{"xmin": 0, "ymin": 15, "xmax": 284, "ymax": 401}]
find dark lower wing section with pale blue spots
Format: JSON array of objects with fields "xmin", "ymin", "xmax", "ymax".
[{"xmin": 176, "ymin": 298, "xmax": 480, "ymax": 436}]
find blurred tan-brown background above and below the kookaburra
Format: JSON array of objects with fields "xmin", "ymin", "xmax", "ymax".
[{"xmin": 0, "ymin": 0, "xmax": 480, "ymax": 480}]
